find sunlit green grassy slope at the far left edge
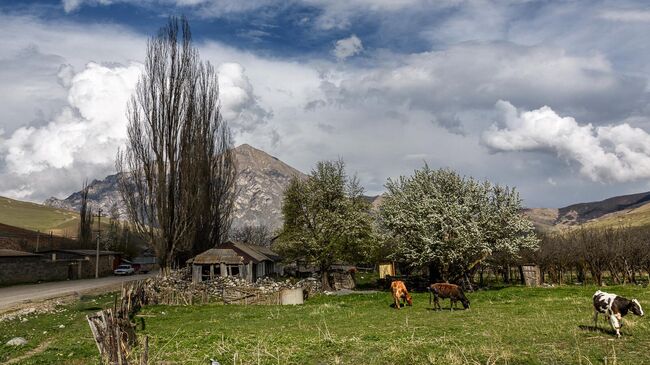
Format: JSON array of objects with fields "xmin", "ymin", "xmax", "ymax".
[{"xmin": 0, "ymin": 197, "xmax": 79, "ymax": 235}]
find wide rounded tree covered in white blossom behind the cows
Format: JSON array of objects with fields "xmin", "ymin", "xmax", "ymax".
[{"xmin": 380, "ymin": 165, "xmax": 537, "ymax": 280}]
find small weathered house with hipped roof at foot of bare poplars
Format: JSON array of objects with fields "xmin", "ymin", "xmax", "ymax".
[{"xmin": 188, "ymin": 241, "xmax": 282, "ymax": 282}]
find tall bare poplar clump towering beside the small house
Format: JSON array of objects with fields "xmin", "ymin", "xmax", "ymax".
[{"xmin": 116, "ymin": 17, "xmax": 236, "ymax": 272}]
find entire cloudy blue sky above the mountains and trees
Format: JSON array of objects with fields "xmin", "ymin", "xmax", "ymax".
[{"xmin": 0, "ymin": 0, "xmax": 650, "ymax": 207}]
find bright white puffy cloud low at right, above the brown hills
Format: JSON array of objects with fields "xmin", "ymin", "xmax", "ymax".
[{"xmin": 482, "ymin": 100, "xmax": 650, "ymax": 182}]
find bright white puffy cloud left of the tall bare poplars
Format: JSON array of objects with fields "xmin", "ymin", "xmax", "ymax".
[{"xmin": 0, "ymin": 62, "xmax": 141, "ymax": 175}]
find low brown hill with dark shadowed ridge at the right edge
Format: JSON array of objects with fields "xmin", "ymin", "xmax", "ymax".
[{"xmin": 524, "ymin": 192, "xmax": 650, "ymax": 230}]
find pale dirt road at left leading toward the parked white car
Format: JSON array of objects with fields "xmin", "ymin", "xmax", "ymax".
[{"xmin": 0, "ymin": 273, "xmax": 156, "ymax": 312}]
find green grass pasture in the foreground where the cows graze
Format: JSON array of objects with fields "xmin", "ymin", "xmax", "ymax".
[{"xmin": 0, "ymin": 286, "xmax": 650, "ymax": 364}]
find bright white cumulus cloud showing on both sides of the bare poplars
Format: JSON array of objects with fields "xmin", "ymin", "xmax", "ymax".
[{"xmin": 0, "ymin": 53, "xmax": 266, "ymax": 199}]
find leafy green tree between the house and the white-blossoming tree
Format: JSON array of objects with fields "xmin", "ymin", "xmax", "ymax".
[{"xmin": 276, "ymin": 160, "xmax": 373, "ymax": 290}]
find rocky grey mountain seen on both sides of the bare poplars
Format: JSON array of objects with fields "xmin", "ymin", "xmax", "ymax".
[{"xmin": 44, "ymin": 144, "xmax": 305, "ymax": 229}]
